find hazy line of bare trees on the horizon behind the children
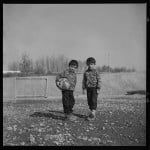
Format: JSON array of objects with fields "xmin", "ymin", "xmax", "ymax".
[{"xmin": 5, "ymin": 53, "xmax": 135, "ymax": 76}]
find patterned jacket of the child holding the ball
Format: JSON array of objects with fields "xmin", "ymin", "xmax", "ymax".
[{"xmin": 56, "ymin": 68, "xmax": 77, "ymax": 91}]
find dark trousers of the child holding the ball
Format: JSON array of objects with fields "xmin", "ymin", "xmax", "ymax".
[{"xmin": 62, "ymin": 90, "xmax": 75, "ymax": 114}]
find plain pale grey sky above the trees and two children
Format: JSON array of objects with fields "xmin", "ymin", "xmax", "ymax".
[{"xmin": 3, "ymin": 4, "xmax": 146, "ymax": 70}]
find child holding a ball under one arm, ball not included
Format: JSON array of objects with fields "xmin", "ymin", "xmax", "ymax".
[{"xmin": 56, "ymin": 60, "xmax": 78, "ymax": 120}]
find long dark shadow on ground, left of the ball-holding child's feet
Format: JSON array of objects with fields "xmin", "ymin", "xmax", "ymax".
[{"xmin": 30, "ymin": 111, "xmax": 66, "ymax": 120}]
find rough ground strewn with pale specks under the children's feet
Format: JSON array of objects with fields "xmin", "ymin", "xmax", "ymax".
[{"xmin": 3, "ymin": 95, "xmax": 146, "ymax": 146}]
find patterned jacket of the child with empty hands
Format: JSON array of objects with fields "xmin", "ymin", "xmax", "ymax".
[{"xmin": 82, "ymin": 68, "xmax": 101, "ymax": 89}]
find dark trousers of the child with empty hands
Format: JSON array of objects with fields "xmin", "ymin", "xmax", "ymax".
[{"xmin": 87, "ymin": 88, "xmax": 98, "ymax": 110}]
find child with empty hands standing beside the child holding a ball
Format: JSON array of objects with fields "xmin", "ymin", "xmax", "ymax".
[{"xmin": 82, "ymin": 57, "xmax": 101, "ymax": 120}]
